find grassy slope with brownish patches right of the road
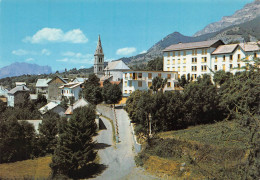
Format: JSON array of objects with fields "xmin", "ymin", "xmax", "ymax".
[{"xmin": 136, "ymin": 121, "xmax": 249, "ymax": 179}]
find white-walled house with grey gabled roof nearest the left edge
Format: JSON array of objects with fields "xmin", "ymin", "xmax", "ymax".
[{"xmin": 7, "ymin": 85, "xmax": 30, "ymax": 107}]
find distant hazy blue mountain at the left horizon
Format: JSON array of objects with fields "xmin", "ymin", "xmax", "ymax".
[{"xmin": 0, "ymin": 62, "xmax": 52, "ymax": 79}]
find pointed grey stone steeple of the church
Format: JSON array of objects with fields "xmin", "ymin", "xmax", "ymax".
[{"xmin": 94, "ymin": 35, "xmax": 104, "ymax": 77}]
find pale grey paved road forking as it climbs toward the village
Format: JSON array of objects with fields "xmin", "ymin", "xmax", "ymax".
[{"xmin": 95, "ymin": 106, "xmax": 156, "ymax": 180}]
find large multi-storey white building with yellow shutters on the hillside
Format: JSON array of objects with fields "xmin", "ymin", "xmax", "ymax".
[{"xmin": 163, "ymin": 40, "xmax": 260, "ymax": 80}]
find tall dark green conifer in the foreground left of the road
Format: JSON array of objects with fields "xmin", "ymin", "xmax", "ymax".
[{"xmin": 50, "ymin": 106, "xmax": 96, "ymax": 177}]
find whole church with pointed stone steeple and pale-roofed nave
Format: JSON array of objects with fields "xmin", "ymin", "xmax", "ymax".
[{"xmin": 94, "ymin": 35, "xmax": 130, "ymax": 81}]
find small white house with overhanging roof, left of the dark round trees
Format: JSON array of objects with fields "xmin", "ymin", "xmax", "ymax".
[{"xmin": 59, "ymin": 82, "xmax": 83, "ymax": 100}]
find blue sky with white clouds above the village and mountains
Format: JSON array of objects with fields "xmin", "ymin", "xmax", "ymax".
[{"xmin": 0, "ymin": 0, "xmax": 253, "ymax": 71}]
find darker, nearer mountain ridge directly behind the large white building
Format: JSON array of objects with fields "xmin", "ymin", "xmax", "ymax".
[{"xmin": 121, "ymin": 11, "xmax": 260, "ymax": 66}]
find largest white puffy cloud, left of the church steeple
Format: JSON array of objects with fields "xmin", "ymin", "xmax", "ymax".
[{"xmin": 23, "ymin": 28, "xmax": 88, "ymax": 44}]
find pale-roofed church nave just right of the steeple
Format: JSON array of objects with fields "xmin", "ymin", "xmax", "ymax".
[{"xmin": 103, "ymin": 60, "xmax": 130, "ymax": 81}]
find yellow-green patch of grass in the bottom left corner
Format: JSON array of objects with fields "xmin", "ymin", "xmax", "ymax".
[{"xmin": 0, "ymin": 156, "xmax": 51, "ymax": 179}]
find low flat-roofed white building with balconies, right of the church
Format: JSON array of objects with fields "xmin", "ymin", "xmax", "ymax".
[{"xmin": 123, "ymin": 70, "xmax": 178, "ymax": 96}]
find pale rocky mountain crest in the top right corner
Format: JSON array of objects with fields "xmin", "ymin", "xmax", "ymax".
[{"xmin": 194, "ymin": 0, "xmax": 260, "ymax": 36}]
